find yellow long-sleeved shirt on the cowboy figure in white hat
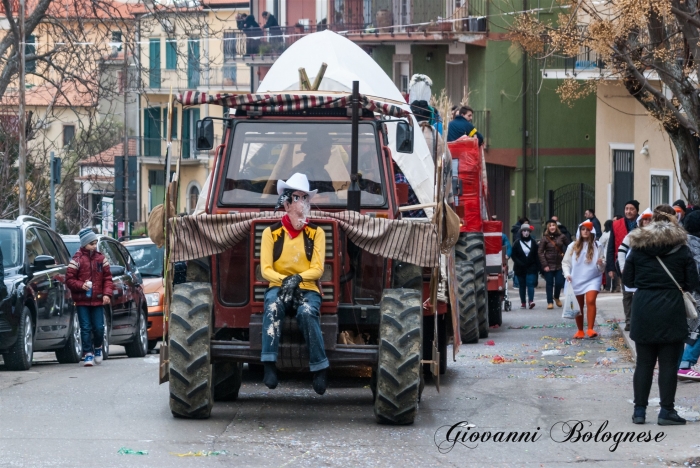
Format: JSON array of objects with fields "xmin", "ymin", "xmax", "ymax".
[{"xmin": 260, "ymin": 223, "xmax": 326, "ymax": 293}]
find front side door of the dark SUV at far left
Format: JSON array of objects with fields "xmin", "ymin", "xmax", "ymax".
[{"xmin": 24, "ymin": 228, "xmax": 58, "ymax": 342}]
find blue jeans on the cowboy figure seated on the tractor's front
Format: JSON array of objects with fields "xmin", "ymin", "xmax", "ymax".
[{"xmin": 260, "ymin": 287, "xmax": 329, "ymax": 372}]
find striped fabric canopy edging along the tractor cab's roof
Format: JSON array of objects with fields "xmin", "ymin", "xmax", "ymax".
[{"xmin": 175, "ymin": 91, "xmax": 410, "ymax": 117}]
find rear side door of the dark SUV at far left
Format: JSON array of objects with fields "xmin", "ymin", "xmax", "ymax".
[{"xmin": 36, "ymin": 228, "xmax": 71, "ymax": 339}]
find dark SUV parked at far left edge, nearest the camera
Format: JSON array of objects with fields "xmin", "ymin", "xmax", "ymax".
[{"xmin": 0, "ymin": 216, "xmax": 82, "ymax": 370}]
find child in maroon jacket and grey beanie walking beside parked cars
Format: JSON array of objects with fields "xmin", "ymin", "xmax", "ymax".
[{"xmin": 66, "ymin": 228, "xmax": 113, "ymax": 367}]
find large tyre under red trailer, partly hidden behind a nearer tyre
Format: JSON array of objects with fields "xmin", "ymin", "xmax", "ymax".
[{"xmin": 455, "ymin": 232, "xmax": 489, "ymax": 338}]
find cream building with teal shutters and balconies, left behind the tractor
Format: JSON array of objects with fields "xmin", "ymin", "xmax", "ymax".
[{"xmin": 133, "ymin": 0, "xmax": 250, "ymax": 221}]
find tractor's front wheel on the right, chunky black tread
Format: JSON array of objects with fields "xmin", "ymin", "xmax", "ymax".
[{"xmin": 374, "ymin": 289, "xmax": 423, "ymax": 424}]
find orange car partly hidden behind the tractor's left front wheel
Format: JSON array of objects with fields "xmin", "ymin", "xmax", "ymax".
[{"xmin": 122, "ymin": 237, "xmax": 167, "ymax": 350}]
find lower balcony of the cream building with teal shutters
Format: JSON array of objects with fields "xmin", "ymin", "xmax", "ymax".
[{"xmin": 129, "ymin": 135, "xmax": 221, "ymax": 165}]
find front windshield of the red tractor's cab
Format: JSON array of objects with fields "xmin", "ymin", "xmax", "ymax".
[{"xmin": 219, "ymin": 121, "xmax": 386, "ymax": 207}]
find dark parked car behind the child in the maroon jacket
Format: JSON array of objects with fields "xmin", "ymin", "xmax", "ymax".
[{"xmin": 63, "ymin": 235, "xmax": 148, "ymax": 359}]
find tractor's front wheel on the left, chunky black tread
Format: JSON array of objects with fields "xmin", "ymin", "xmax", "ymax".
[{"xmin": 168, "ymin": 283, "xmax": 214, "ymax": 419}]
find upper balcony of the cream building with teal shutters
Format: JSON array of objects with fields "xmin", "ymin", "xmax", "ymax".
[{"xmin": 142, "ymin": 63, "xmax": 250, "ymax": 94}]
